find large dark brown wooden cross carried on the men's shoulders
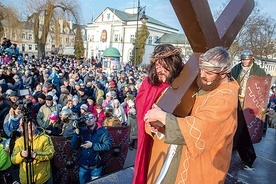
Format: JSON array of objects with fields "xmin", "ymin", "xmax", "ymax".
[{"xmin": 157, "ymin": 0, "xmax": 254, "ymax": 117}]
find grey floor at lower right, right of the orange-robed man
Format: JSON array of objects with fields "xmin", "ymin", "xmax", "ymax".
[{"xmin": 226, "ymin": 128, "xmax": 276, "ymax": 184}]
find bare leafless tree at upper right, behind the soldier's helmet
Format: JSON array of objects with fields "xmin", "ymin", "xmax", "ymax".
[{"xmin": 214, "ymin": 0, "xmax": 276, "ymax": 61}]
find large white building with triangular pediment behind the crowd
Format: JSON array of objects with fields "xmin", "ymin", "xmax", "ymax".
[{"xmin": 86, "ymin": 7, "xmax": 181, "ymax": 64}]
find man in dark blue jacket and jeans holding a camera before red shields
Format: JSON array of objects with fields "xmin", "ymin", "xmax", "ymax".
[{"xmin": 71, "ymin": 114, "xmax": 111, "ymax": 184}]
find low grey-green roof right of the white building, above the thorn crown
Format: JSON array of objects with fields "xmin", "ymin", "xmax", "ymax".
[{"xmin": 155, "ymin": 33, "xmax": 189, "ymax": 44}]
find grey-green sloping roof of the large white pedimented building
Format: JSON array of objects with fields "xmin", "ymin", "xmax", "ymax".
[{"xmin": 106, "ymin": 7, "xmax": 178, "ymax": 31}]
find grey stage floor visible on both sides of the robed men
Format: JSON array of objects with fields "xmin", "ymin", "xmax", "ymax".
[{"xmin": 92, "ymin": 128, "xmax": 276, "ymax": 184}]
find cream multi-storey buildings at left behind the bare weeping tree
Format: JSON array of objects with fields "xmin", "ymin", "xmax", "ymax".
[{"xmin": 1, "ymin": 18, "xmax": 86, "ymax": 55}]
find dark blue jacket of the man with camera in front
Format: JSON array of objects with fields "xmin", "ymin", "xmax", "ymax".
[{"xmin": 71, "ymin": 125, "xmax": 111, "ymax": 169}]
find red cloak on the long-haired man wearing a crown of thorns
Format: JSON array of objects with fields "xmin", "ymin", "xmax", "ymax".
[{"xmin": 132, "ymin": 78, "xmax": 168, "ymax": 184}]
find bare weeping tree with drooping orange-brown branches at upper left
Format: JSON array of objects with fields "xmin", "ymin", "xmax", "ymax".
[{"xmin": 24, "ymin": 0, "xmax": 80, "ymax": 57}]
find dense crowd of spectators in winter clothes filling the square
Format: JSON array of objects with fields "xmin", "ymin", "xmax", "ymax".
[{"xmin": 0, "ymin": 40, "xmax": 142, "ymax": 183}]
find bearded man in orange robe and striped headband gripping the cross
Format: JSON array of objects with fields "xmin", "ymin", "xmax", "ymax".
[{"xmin": 144, "ymin": 47, "xmax": 239, "ymax": 184}]
